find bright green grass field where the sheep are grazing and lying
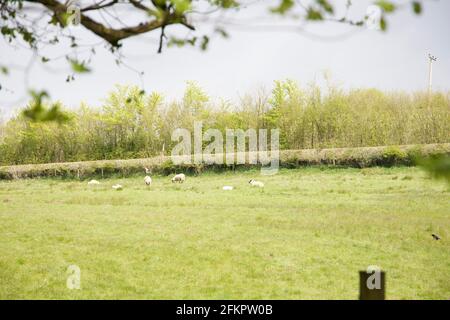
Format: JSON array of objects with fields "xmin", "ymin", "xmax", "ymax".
[{"xmin": 0, "ymin": 167, "xmax": 450, "ymax": 299}]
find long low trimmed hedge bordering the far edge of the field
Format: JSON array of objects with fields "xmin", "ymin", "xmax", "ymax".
[{"xmin": 0, "ymin": 143, "xmax": 450, "ymax": 179}]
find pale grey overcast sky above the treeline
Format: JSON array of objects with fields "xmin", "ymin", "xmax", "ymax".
[{"xmin": 0, "ymin": 0, "xmax": 450, "ymax": 117}]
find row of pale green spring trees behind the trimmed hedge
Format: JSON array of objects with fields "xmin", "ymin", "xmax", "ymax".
[{"xmin": 0, "ymin": 80, "xmax": 450, "ymax": 165}]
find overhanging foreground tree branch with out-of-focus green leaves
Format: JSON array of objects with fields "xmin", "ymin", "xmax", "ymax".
[{"xmin": 0, "ymin": 0, "xmax": 422, "ymax": 120}]
